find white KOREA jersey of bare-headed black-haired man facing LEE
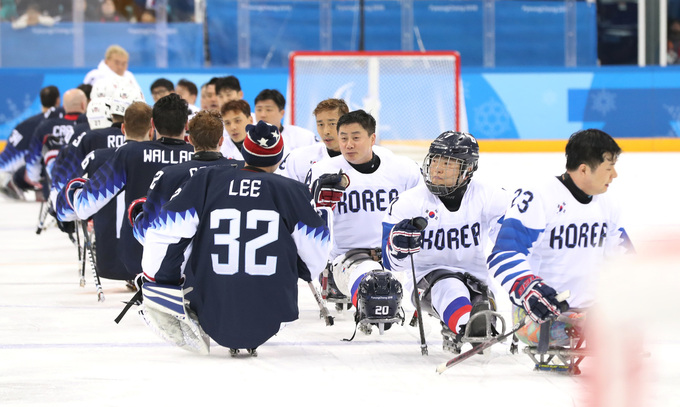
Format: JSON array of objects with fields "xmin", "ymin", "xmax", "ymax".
[{"xmin": 310, "ymin": 149, "xmax": 423, "ymax": 260}]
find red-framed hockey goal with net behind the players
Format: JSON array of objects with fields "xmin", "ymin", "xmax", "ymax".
[{"xmin": 288, "ymin": 51, "xmax": 467, "ymax": 141}]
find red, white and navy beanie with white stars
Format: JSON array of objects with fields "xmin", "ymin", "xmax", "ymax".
[{"xmin": 241, "ymin": 120, "xmax": 283, "ymax": 167}]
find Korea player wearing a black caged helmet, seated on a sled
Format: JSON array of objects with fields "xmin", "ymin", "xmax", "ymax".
[{"xmin": 382, "ymin": 131, "xmax": 511, "ymax": 353}]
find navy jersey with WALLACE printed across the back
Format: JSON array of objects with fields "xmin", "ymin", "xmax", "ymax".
[{"xmin": 55, "ymin": 138, "xmax": 193, "ymax": 280}]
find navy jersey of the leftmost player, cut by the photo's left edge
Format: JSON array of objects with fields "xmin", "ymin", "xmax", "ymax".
[{"xmin": 0, "ymin": 108, "xmax": 63, "ymax": 172}]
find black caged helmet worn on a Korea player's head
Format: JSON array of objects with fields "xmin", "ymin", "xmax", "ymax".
[{"xmin": 422, "ymin": 131, "xmax": 479, "ymax": 196}]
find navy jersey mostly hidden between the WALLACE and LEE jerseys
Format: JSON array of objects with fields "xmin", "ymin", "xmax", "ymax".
[{"xmin": 132, "ymin": 151, "xmax": 245, "ymax": 244}]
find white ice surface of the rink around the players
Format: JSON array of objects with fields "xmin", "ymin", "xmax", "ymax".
[{"xmin": 0, "ymin": 153, "xmax": 680, "ymax": 407}]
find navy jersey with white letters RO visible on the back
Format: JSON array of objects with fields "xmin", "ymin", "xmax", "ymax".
[{"xmin": 51, "ymin": 123, "xmax": 125, "ymax": 191}]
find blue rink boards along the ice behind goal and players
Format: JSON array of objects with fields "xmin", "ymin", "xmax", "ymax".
[{"xmin": 0, "ymin": 67, "xmax": 680, "ymax": 140}]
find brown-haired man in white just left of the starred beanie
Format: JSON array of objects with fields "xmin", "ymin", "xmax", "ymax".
[{"xmin": 220, "ymin": 99, "xmax": 253, "ymax": 160}]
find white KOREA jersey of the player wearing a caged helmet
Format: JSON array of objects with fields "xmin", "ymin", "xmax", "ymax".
[{"xmin": 383, "ymin": 182, "xmax": 511, "ymax": 291}]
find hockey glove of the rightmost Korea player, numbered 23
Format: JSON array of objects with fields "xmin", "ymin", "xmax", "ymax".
[{"xmin": 510, "ymin": 274, "xmax": 569, "ymax": 324}]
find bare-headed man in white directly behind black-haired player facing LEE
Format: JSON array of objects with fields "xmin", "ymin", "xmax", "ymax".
[{"xmin": 277, "ymin": 99, "xmax": 349, "ymax": 182}]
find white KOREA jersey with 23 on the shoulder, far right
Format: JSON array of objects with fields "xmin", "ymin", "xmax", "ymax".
[{"xmin": 488, "ymin": 177, "xmax": 628, "ymax": 308}]
